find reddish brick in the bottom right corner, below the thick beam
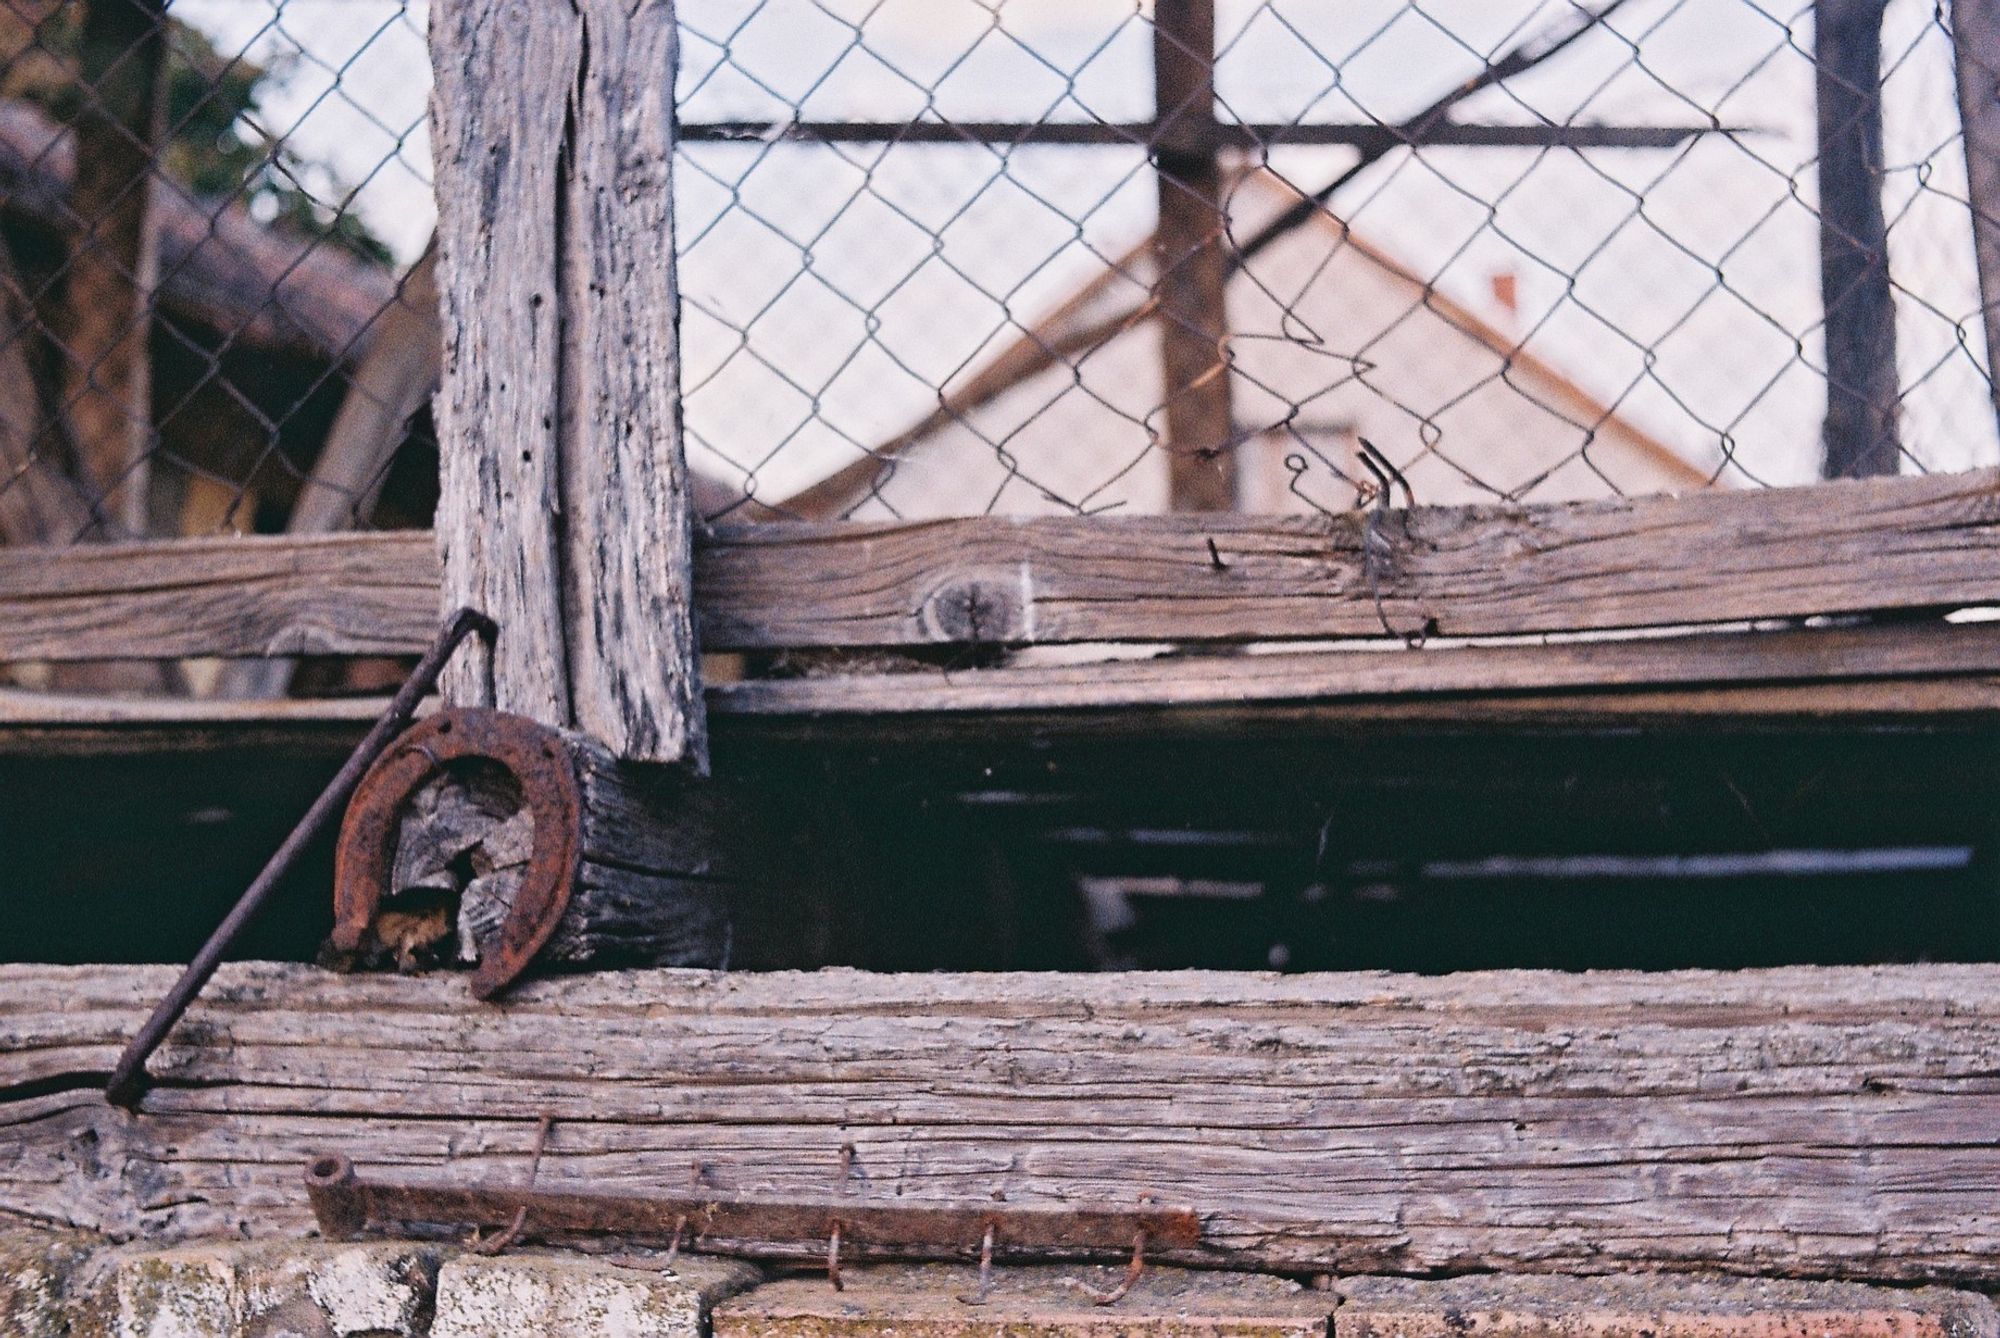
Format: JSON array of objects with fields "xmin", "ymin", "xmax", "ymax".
[{"xmin": 1334, "ymin": 1274, "xmax": 2000, "ymax": 1338}]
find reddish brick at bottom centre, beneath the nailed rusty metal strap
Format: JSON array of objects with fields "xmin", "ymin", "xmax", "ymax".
[{"xmin": 714, "ymin": 1264, "xmax": 1334, "ymax": 1338}]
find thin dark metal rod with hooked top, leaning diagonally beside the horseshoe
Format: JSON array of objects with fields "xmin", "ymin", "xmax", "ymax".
[{"xmin": 104, "ymin": 608, "xmax": 498, "ymax": 1110}]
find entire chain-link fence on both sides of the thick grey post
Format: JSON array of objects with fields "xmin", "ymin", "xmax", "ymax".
[{"xmin": 0, "ymin": 0, "xmax": 2000, "ymax": 542}]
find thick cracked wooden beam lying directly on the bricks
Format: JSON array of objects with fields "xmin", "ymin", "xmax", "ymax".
[{"xmin": 11, "ymin": 964, "xmax": 2000, "ymax": 1282}]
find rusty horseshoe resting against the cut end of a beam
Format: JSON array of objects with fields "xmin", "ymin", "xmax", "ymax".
[{"xmin": 332, "ymin": 708, "xmax": 584, "ymax": 998}]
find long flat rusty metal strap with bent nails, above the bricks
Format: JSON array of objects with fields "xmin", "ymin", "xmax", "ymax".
[{"xmin": 306, "ymin": 1154, "xmax": 1202, "ymax": 1272}]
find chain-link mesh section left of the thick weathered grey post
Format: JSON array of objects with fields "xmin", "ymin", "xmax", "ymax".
[{"xmin": 0, "ymin": 0, "xmax": 436, "ymax": 544}]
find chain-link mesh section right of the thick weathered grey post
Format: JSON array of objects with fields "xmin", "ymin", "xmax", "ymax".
[{"xmin": 680, "ymin": 0, "xmax": 1996, "ymax": 516}]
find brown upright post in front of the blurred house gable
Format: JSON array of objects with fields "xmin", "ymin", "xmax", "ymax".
[{"xmin": 1152, "ymin": 0, "xmax": 1236, "ymax": 512}]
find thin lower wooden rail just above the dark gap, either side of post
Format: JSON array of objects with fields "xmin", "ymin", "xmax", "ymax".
[{"xmin": 0, "ymin": 622, "xmax": 2000, "ymax": 756}]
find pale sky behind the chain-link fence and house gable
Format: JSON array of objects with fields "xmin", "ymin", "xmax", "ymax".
[{"xmin": 160, "ymin": 0, "xmax": 2000, "ymax": 498}]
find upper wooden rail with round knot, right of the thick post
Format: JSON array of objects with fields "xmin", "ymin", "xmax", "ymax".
[{"xmin": 696, "ymin": 470, "xmax": 2000, "ymax": 650}]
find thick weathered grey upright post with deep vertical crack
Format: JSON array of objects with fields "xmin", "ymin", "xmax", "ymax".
[{"xmin": 430, "ymin": 0, "xmax": 706, "ymax": 768}]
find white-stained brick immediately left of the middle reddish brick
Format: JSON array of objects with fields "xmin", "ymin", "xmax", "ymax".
[{"xmin": 430, "ymin": 1250, "xmax": 758, "ymax": 1338}]
